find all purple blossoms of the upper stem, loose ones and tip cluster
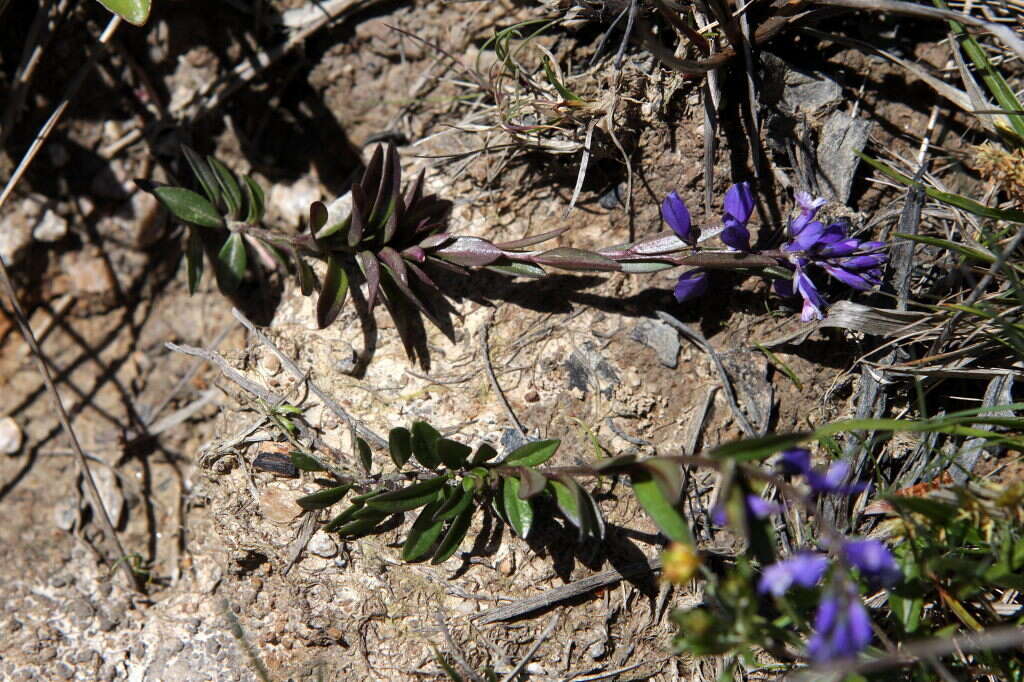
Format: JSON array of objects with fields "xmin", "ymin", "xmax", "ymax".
[{"xmin": 662, "ymin": 182, "xmax": 888, "ymax": 322}]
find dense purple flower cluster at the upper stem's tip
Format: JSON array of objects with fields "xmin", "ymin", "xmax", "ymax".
[{"xmin": 775, "ymin": 191, "xmax": 888, "ymax": 322}]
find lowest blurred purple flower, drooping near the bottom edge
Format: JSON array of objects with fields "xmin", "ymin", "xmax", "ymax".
[{"xmin": 807, "ymin": 586, "xmax": 871, "ymax": 664}]
